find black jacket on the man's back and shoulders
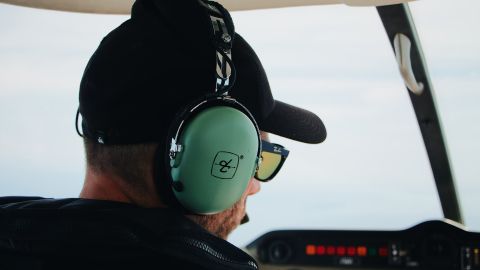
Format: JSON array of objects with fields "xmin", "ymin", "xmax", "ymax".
[{"xmin": 0, "ymin": 197, "xmax": 258, "ymax": 270}]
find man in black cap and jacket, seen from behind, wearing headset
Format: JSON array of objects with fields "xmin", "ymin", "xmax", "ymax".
[{"xmin": 0, "ymin": 0, "xmax": 326, "ymax": 269}]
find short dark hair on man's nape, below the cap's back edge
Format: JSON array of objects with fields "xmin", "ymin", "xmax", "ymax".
[{"xmin": 84, "ymin": 139, "xmax": 158, "ymax": 190}]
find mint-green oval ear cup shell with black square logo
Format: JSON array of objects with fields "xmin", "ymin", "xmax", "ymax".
[{"xmin": 171, "ymin": 106, "xmax": 260, "ymax": 214}]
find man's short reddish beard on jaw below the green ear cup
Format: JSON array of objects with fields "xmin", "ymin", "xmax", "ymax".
[{"xmin": 188, "ymin": 198, "xmax": 246, "ymax": 240}]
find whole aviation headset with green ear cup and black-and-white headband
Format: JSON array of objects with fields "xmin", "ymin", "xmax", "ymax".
[{"xmin": 165, "ymin": 0, "xmax": 261, "ymax": 214}]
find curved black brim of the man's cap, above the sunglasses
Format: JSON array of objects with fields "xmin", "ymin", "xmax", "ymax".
[{"xmin": 258, "ymin": 100, "xmax": 327, "ymax": 143}]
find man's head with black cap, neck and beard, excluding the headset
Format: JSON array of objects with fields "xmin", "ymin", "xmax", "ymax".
[{"xmin": 80, "ymin": 1, "xmax": 325, "ymax": 236}]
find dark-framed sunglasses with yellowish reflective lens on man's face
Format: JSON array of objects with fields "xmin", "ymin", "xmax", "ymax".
[{"xmin": 255, "ymin": 140, "xmax": 290, "ymax": 182}]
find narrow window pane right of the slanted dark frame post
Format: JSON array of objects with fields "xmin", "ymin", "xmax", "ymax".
[{"xmin": 410, "ymin": 0, "xmax": 480, "ymax": 231}]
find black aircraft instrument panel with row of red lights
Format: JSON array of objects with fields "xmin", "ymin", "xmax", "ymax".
[{"xmin": 247, "ymin": 221, "xmax": 480, "ymax": 270}]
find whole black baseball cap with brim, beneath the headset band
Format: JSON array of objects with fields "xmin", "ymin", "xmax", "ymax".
[{"xmin": 79, "ymin": 0, "xmax": 326, "ymax": 144}]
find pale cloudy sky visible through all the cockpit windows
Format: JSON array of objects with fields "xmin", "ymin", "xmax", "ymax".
[{"xmin": 0, "ymin": 0, "xmax": 480, "ymax": 246}]
